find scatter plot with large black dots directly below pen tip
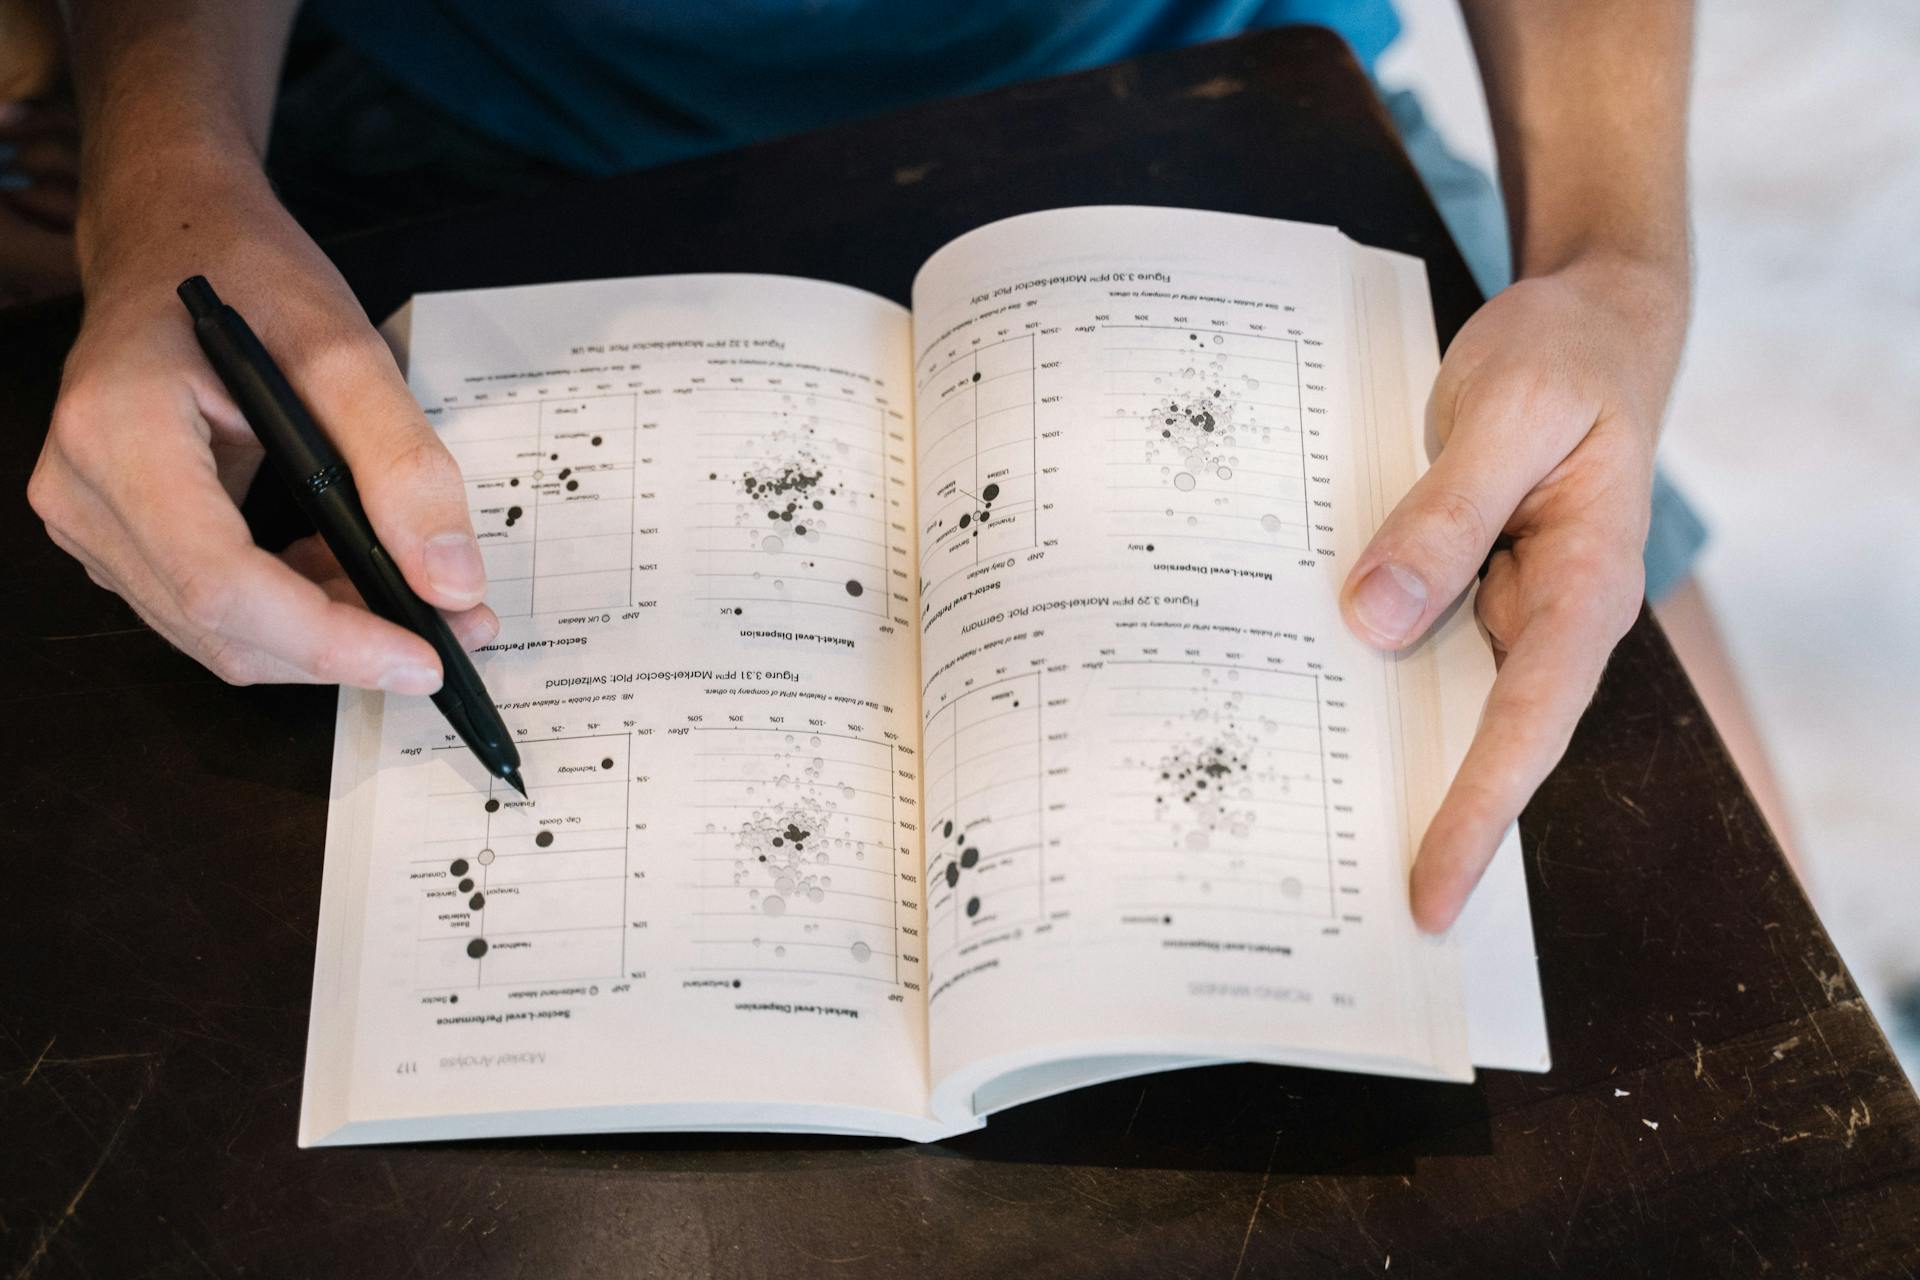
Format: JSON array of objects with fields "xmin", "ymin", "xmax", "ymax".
[{"xmin": 409, "ymin": 735, "xmax": 630, "ymax": 988}]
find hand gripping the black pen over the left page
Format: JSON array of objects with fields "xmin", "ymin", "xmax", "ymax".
[{"xmin": 27, "ymin": 167, "xmax": 499, "ymax": 693}]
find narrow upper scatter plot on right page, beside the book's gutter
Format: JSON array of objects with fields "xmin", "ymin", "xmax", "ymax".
[{"xmin": 918, "ymin": 336, "xmax": 1039, "ymax": 585}]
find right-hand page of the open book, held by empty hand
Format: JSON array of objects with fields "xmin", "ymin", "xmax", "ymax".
[{"xmin": 914, "ymin": 209, "xmax": 1471, "ymax": 1105}]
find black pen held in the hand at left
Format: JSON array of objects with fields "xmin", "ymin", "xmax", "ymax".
[{"xmin": 177, "ymin": 276, "xmax": 526, "ymax": 796}]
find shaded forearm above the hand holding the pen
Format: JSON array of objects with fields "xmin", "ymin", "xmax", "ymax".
[{"xmin": 69, "ymin": 0, "xmax": 298, "ymax": 278}]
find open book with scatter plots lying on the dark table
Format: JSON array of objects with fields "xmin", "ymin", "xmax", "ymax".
[{"xmin": 300, "ymin": 207, "xmax": 1548, "ymax": 1144}]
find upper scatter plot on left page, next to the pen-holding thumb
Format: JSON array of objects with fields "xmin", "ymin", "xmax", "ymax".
[{"xmin": 434, "ymin": 393, "xmax": 636, "ymax": 618}]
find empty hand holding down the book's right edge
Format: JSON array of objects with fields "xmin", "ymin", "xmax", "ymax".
[{"xmin": 1340, "ymin": 257, "xmax": 1686, "ymax": 933}]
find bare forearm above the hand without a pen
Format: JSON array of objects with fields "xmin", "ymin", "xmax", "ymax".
[{"xmin": 1461, "ymin": 0, "xmax": 1693, "ymax": 280}]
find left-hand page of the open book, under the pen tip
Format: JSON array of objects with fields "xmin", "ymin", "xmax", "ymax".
[{"xmin": 303, "ymin": 276, "xmax": 944, "ymax": 1142}]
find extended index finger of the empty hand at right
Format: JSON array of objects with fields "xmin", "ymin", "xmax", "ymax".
[{"xmin": 1411, "ymin": 601, "xmax": 1613, "ymax": 933}]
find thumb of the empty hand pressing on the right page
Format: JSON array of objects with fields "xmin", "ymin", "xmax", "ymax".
[{"xmin": 1340, "ymin": 432, "xmax": 1538, "ymax": 649}]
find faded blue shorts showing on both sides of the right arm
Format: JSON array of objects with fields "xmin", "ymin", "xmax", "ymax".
[{"xmin": 1380, "ymin": 90, "xmax": 1707, "ymax": 603}]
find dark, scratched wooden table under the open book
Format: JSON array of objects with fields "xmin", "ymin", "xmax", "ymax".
[{"xmin": 0, "ymin": 31, "xmax": 1920, "ymax": 1278}]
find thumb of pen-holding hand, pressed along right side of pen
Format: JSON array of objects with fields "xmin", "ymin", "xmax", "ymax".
[{"xmin": 301, "ymin": 330, "xmax": 486, "ymax": 610}]
